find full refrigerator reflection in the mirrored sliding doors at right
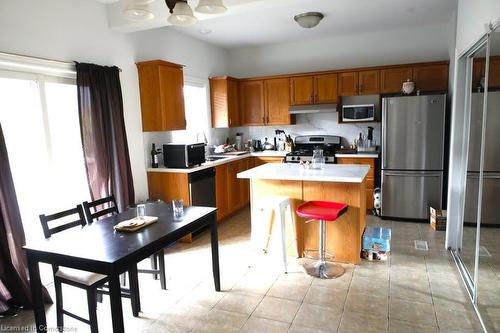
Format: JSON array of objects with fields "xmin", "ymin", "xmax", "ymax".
[{"xmin": 464, "ymin": 91, "xmax": 500, "ymax": 225}]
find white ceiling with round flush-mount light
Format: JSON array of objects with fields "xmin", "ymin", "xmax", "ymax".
[{"xmin": 103, "ymin": 0, "xmax": 457, "ymax": 49}]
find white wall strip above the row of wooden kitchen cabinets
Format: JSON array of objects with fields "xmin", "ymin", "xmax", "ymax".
[{"xmin": 229, "ymin": 22, "xmax": 450, "ymax": 77}]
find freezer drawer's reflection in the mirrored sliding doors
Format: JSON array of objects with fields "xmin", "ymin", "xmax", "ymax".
[{"xmin": 464, "ymin": 173, "xmax": 500, "ymax": 225}]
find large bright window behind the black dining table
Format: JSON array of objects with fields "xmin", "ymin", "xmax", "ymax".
[{"xmin": 0, "ymin": 71, "xmax": 90, "ymax": 240}]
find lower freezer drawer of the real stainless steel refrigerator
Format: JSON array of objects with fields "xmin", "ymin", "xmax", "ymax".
[{"xmin": 382, "ymin": 170, "xmax": 443, "ymax": 219}]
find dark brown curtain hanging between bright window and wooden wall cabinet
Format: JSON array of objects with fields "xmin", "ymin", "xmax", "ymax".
[{"xmin": 76, "ymin": 63, "xmax": 135, "ymax": 211}]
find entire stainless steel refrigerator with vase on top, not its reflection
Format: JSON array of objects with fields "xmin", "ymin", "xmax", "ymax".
[{"xmin": 381, "ymin": 94, "xmax": 446, "ymax": 219}]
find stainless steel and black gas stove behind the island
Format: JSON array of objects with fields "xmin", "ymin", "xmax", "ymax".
[{"xmin": 285, "ymin": 135, "xmax": 340, "ymax": 164}]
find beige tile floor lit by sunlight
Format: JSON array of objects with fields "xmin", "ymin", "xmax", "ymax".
[{"xmin": 0, "ymin": 209, "xmax": 481, "ymax": 333}]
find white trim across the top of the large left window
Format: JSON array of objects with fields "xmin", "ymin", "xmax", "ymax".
[{"xmin": 0, "ymin": 52, "xmax": 76, "ymax": 79}]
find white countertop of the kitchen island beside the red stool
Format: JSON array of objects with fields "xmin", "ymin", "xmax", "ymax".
[{"xmin": 238, "ymin": 163, "xmax": 370, "ymax": 183}]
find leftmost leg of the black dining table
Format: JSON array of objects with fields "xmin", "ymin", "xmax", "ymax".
[{"xmin": 27, "ymin": 252, "xmax": 47, "ymax": 333}]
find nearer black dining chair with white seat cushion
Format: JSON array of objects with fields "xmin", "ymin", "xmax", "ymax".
[{"xmin": 40, "ymin": 205, "xmax": 107, "ymax": 333}]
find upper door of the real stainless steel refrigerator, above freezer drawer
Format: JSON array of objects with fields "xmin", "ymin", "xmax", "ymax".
[{"xmin": 382, "ymin": 95, "xmax": 446, "ymax": 170}]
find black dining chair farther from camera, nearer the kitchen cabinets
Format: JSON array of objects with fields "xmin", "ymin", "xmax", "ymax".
[{"xmin": 83, "ymin": 194, "xmax": 167, "ymax": 290}]
